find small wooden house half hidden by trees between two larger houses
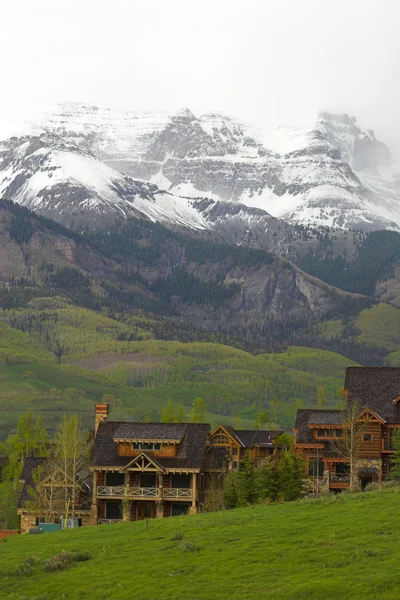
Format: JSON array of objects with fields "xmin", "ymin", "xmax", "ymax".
[{"xmin": 211, "ymin": 425, "xmax": 282, "ymax": 471}]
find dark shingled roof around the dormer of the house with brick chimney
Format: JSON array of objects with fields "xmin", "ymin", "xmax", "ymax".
[{"xmin": 92, "ymin": 421, "xmax": 210, "ymax": 470}]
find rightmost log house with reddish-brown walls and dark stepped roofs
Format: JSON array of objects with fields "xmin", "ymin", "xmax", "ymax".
[{"xmin": 294, "ymin": 367, "xmax": 400, "ymax": 492}]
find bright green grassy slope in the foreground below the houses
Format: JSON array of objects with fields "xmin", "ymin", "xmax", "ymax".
[{"xmin": 0, "ymin": 489, "xmax": 400, "ymax": 600}]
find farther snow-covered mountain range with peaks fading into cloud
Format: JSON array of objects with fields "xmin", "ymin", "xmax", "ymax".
[{"xmin": 25, "ymin": 104, "xmax": 400, "ymax": 230}]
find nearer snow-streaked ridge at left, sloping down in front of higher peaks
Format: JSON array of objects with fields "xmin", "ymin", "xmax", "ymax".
[{"xmin": 0, "ymin": 129, "xmax": 279, "ymax": 240}]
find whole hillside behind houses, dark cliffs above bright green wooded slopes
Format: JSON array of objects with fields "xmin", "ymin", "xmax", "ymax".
[{"xmin": 0, "ymin": 202, "xmax": 400, "ymax": 435}]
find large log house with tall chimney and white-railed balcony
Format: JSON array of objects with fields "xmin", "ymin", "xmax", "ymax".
[{"xmin": 91, "ymin": 404, "xmax": 226, "ymax": 524}]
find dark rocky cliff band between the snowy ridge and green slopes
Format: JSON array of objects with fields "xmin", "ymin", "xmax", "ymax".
[{"xmin": 0, "ymin": 202, "xmax": 362, "ymax": 347}]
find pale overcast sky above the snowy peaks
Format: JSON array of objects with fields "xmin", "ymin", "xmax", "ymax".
[{"xmin": 0, "ymin": 0, "xmax": 400, "ymax": 154}]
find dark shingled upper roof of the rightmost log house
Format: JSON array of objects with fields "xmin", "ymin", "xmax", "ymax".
[{"xmin": 344, "ymin": 367, "xmax": 400, "ymax": 423}]
